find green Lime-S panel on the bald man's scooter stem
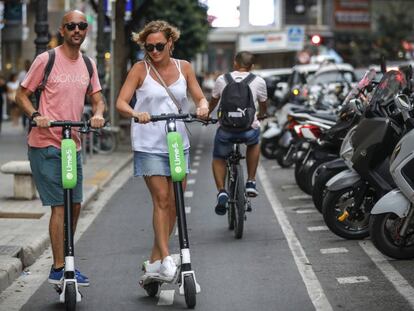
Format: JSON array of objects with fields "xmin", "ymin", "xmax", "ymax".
[{"xmin": 61, "ymin": 139, "xmax": 78, "ymax": 189}]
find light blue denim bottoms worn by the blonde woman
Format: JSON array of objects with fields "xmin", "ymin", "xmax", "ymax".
[{"xmin": 134, "ymin": 150, "xmax": 190, "ymax": 176}]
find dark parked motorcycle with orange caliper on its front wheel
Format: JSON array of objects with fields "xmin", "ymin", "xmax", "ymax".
[{"xmin": 322, "ymin": 71, "xmax": 406, "ymax": 239}]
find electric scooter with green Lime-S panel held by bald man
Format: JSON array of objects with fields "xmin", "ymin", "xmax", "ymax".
[{"xmin": 31, "ymin": 121, "xmax": 101, "ymax": 311}]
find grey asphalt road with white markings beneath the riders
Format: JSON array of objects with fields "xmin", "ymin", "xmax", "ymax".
[{"xmin": 14, "ymin": 126, "xmax": 414, "ymax": 311}]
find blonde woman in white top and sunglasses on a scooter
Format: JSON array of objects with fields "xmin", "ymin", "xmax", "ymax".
[{"xmin": 116, "ymin": 21, "xmax": 208, "ymax": 281}]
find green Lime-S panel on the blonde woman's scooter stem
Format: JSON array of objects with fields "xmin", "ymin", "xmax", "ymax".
[{"xmin": 167, "ymin": 132, "xmax": 187, "ymax": 181}]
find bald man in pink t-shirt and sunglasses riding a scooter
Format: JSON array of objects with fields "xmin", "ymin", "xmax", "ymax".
[{"xmin": 17, "ymin": 11, "xmax": 105, "ymax": 286}]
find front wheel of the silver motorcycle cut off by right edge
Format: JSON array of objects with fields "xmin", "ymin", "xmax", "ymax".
[{"xmin": 369, "ymin": 213, "xmax": 414, "ymax": 259}]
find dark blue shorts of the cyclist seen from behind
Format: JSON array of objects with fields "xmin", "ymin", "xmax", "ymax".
[{"xmin": 213, "ymin": 127, "xmax": 260, "ymax": 159}]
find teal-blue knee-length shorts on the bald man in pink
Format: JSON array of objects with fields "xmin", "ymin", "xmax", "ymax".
[{"xmin": 28, "ymin": 146, "xmax": 83, "ymax": 206}]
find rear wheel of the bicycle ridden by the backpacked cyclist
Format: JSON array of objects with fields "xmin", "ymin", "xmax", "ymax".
[{"xmin": 234, "ymin": 164, "xmax": 246, "ymax": 239}]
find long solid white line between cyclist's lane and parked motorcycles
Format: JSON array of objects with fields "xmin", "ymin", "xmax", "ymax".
[{"xmin": 258, "ymin": 165, "xmax": 333, "ymax": 311}]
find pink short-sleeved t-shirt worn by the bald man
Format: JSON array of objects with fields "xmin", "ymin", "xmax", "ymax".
[{"xmin": 21, "ymin": 46, "xmax": 101, "ymax": 150}]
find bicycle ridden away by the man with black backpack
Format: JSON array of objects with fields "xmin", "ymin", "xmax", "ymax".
[{"xmin": 225, "ymin": 141, "xmax": 252, "ymax": 239}]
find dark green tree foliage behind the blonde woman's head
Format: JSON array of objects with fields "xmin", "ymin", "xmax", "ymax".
[{"xmin": 139, "ymin": 0, "xmax": 209, "ymax": 60}]
